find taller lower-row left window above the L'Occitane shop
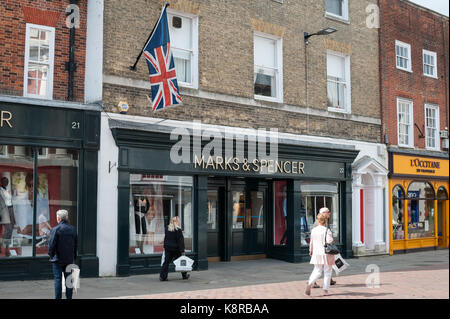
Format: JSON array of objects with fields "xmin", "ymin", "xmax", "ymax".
[{"xmin": 397, "ymin": 98, "xmax": 414, "ymax": 147}]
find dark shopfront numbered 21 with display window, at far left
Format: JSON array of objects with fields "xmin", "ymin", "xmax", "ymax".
[{"xmin": 0, "ymin": 97, "xmax": 100, "ymax": 280}]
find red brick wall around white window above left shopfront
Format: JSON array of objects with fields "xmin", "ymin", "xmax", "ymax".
[{"xmin": 0, "ymin": 0, "xmax": 87, "ymax": 102}]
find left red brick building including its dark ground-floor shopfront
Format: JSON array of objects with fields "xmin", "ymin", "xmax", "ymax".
[{"xmin": 0, "ymin": 0, "xmax": 101, "ymax": 280}]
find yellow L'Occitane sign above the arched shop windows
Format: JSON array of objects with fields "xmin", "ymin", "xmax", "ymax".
[{"xmin": 392, "ymin": 154, "xmax": 449, "ymax": 178}]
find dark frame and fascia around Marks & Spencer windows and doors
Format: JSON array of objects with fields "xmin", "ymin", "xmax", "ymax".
[{"xmin": 109, "ymin": 120, "xmax": 358, "ymax": 276}]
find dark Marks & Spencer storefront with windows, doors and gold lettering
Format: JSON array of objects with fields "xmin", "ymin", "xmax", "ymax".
[{"xmin": 109, "ymin": 120, "xmax": 358, "ymax": 276}]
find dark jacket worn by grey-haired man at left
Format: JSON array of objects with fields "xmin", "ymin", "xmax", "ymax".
[{"xmin": 48, "ymin": 220, "xmax": 78, "ymax": 265}]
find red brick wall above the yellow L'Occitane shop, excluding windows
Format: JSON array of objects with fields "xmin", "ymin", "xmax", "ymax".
[{"xmin": 379, "ymin": 0, "xmax": 449, "ymax": 149}]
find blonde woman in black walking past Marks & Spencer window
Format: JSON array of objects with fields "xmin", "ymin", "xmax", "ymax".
[{"xmin": 159, "ymin": 216, "xmax": 189, "ymax": 281}]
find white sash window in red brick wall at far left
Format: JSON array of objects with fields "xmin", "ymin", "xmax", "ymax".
[{"xmin": 24, "ymin": 23, "xmax": 55, "ymax": 99}]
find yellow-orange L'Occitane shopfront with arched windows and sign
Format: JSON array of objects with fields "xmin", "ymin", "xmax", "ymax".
[{"xmin": 389, "ymin": 153, "xmax": 449, "ymax": 255}]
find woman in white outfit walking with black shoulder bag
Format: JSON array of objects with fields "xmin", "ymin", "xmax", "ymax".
[{"xmin": 305, "ymin": 213, "xmax": 334, "ymax": 296}]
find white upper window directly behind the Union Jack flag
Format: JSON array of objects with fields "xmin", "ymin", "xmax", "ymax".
[{"xmin": 167, "ymin": 10, "xmax": 198, "ymax": 89}]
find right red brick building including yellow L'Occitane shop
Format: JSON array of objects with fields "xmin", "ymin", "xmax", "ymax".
[{"xmin": 379, "ymin": 0, "xmax": 449, "ymax": 254}]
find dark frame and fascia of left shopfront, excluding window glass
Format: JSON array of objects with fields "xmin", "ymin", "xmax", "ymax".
[{"xmin": 0, "ymin": 102, "xmax": 100, "ymax": 280}]
